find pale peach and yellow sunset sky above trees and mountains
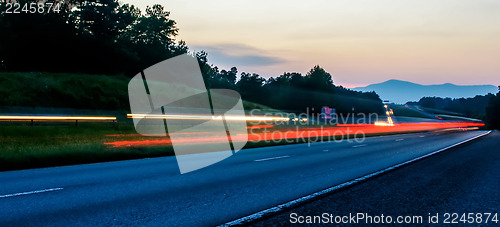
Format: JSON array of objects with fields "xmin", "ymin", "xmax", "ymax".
[{"xmin": 123, "ymin": 0, "xmax": 500, "ymax": 87}]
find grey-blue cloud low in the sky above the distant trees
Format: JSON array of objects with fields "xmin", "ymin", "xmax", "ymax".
[{"xmin": 191, "ymin": 44, "xmax": 287, "ymax": 67}]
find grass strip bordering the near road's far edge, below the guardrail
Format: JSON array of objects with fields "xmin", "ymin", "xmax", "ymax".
[{"xmin": 0, "ymin": 125, "xmax": 438, "ymax": 171}]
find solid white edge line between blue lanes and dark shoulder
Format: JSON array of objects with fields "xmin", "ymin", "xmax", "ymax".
[{"xmin": 219, "ymin": 131, "xmax": 491, "ymax": 226}]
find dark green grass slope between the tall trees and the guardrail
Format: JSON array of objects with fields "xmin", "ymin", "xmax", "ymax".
[{"xmin": 0, "ymin": 73, "xmax": 129, "ymax": 110}]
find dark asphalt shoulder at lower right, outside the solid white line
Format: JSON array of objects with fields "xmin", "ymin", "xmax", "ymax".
[{"xmin": 253, "ymin": 132, "xmax": 500, "ymax": 226}]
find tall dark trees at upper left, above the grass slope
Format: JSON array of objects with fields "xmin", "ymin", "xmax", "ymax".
[{"xmin": 0, "ymin": 0, "xmax": 187, "ymax": 76}]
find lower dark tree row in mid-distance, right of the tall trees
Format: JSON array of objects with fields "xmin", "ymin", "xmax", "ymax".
[{"xmin": 197, "ymin": 55, "xmax": 382, "ymax": 113}]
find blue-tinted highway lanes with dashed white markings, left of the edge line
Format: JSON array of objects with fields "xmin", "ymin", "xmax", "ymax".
[{"xmin": 0, "ymin": 131, "xmax": 492, "ymax": 226}]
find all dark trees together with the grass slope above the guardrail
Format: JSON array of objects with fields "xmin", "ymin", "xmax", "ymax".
[{"xmin": 0, "ymin": 0, "xmax": 382, "ymax": 113}]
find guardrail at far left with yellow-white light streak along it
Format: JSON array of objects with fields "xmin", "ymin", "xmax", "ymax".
[{"xmin": 0, "ymin": 115, "xmax": 116, "ymax": 127}]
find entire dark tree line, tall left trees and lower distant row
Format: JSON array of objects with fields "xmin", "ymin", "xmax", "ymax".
[{"xmin": 0, "ymin": 0, "xmax": 382, "ymax": 113}]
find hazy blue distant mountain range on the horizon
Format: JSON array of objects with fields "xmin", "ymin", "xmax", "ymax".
[{"xmin": 352, "ymin": 80, "xmax": 498, "ymax": 104}]
